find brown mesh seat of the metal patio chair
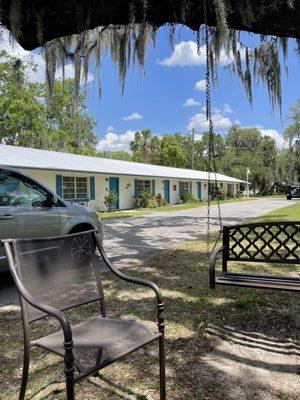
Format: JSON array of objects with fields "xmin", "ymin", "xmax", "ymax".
[{"xmin": 32, "ymin": 317, "xmax": 161, "ymax": 373}]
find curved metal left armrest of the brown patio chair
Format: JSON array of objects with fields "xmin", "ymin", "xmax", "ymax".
[{"xmin": 4, "ymin": 241, "xmax": 72, "ymax": 342}]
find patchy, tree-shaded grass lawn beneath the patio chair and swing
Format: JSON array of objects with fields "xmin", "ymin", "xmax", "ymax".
[{"xmin": 0, "ymin": 203, "xmax": 300, "ymax": 400}]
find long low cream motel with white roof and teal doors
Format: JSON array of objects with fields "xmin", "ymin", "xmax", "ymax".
[{"xmin": 0, "ymin": 145, "xmax": 244, "ymax": 211}]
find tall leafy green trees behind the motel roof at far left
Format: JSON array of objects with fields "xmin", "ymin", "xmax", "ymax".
[{"xmin": 0, "ymin": 52, "xmax": 97, "ymax": 155}]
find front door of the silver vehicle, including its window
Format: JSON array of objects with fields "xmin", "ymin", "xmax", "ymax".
[{"xmin": 0, "ymin": 170, "xmax": 60, "ymax": 239}]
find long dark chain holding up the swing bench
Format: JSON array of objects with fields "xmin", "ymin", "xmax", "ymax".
[{"xmin": 204, "ymin": 0, "xmax": 222, "ymax": 258}]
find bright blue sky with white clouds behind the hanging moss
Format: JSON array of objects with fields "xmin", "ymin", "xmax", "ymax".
[{"xmin": 0, "ymin": 27, "xmax": 300, "ymax": 151}]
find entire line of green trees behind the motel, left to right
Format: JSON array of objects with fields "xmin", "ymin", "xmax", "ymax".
[{"xmin": 0, "ymin": 48, "xmax": 300, "ymax": 194}]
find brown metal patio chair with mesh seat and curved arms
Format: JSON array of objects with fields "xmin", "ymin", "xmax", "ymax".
[{"xmin": 2, "ymin": 231, "xmax": 166, "ymax": 400}]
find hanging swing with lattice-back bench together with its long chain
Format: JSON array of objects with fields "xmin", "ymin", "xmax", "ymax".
[{"xmin": 205, "ymin": 24, "xmax": 300, "ymax": 291}]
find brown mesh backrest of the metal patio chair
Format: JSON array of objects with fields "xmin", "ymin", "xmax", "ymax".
[{"xmin": 12, "ymin": 231, "xmax": 105, "ymax": 322}]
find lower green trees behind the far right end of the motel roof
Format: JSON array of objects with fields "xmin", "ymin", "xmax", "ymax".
[{"xmin": 131, "ymin": 125, "xmax": 290, "ymax": 197}]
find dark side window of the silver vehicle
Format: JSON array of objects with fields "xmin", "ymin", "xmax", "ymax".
[{"xmin": 0, "ymin": 171, "xmax": 49, "ymax": 207}]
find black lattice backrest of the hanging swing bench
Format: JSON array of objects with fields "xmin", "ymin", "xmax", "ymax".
[{"xmin": 223, "ymin": 222, "xmax": 300, "ymax": 264}]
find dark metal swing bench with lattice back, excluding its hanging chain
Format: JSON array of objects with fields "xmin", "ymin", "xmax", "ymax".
[{"xmin": 210, "ymin": 222, "xmax": 300, "ymax": 291}]
